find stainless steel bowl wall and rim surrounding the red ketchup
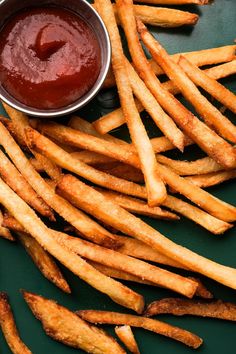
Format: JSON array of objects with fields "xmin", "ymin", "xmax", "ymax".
[{"xmin": 0, "ymin": 0, "xmax": 111, "ymax": 118}]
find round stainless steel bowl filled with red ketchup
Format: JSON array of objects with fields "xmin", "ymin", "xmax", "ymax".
[{"xmin": 0, "ymin": 0, "xmax": 111, "ymax": 117}]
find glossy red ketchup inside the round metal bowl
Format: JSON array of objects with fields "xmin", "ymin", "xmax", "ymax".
[{"xmin": 0, "ymin": 7, "xmax": 101, "ymax": 109}]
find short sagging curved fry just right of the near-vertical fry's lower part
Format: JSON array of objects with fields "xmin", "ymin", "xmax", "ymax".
[{"xmin": 156, "ymin": 155, "xmax": 223, "ymax": 176}]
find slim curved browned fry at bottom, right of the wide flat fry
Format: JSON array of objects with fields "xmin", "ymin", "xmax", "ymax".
[{"xmin": 76, "ymin": 310, "xmax": 202, "ymax": 349}]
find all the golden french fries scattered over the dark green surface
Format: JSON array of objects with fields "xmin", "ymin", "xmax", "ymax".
[{"xmin": 0, "ymin": 0, "xmax": 236, "ymax": 354}]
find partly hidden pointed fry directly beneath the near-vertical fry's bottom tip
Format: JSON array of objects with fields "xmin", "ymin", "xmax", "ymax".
[{"xmin": 96, "ymin": 188, "xmax": 179, "ymax": 220}]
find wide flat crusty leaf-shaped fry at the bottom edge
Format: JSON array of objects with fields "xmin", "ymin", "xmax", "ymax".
[{"xmin": 23, "ymin": 291, "xmax": 125, "ymax": 354}]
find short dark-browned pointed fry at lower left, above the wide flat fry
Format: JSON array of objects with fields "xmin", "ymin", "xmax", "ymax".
[{"xmin": 17, "ymin": 232, "xmax": 71, "ymax": 294}]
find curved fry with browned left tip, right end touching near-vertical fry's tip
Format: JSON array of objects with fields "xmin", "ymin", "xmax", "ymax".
[{"xmin": 27, "ymin": 128, "xmax": 147, "ymax": 198}]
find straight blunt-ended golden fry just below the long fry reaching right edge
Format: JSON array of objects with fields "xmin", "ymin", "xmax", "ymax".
[{"xmin": 52, "ymin": 233, "xmax": 198, "ymax": 298}]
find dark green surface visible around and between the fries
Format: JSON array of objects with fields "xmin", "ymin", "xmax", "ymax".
[{"xmin": 0, "ymin": 0, "xmax": 236, "ymax": 354}]
